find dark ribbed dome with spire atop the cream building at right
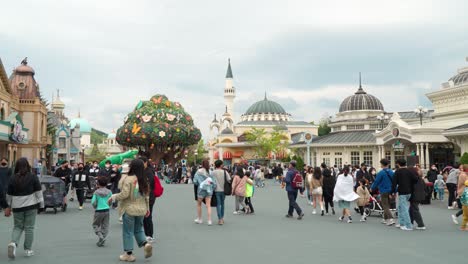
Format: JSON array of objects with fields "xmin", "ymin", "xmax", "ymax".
[{"xmin": 340, "ymin": 86, "xmax": 384, "ymax": 112}]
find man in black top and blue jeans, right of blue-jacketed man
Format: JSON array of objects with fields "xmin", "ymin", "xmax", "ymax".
[{"xmin": 392, "ymin": 159, "xmax": 418, "ymax": 231}]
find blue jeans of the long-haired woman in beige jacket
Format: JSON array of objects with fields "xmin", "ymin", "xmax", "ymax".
[{"xmin": 122, "ymin": 214, "xmax": 146, "ymax": 252}]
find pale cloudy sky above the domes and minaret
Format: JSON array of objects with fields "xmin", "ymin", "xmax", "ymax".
[{"xmin": 0, "ymin": 0, "xmax": 468, "ymax": 136}]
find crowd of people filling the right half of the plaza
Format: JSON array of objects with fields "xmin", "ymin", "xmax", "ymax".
[{"xmin": 193, "ymin": 159, "xmax": 468, "ymax": 231}]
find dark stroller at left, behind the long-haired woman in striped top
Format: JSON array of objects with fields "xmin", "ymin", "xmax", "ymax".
[{"xmin": 41, "ymin": 176, "xmax": 67, "ymax": 214}]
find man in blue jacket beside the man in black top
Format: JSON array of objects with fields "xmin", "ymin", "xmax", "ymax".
[{"xmin": 371, "ymin": 159, "xmax": 395, "ymax": 226}]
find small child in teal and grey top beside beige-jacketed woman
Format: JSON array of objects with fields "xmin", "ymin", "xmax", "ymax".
[{"xmin": 91, "ymin": 177, "xmax": 112, "ymax": 247}]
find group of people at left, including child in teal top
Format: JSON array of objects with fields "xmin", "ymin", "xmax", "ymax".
[{"xmin": 0, "ymin": 157, "xmax": 163, "ymax": 262}]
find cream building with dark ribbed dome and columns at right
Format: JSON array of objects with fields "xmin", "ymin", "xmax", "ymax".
[{"xmin": 291, "ymin": 59, "xmax": 468, "ymax": 169}]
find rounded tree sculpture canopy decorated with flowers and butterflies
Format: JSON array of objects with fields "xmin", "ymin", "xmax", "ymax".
[{"xmin": 116, "ymin": 94, "xmax": 201, "ymax": 165}]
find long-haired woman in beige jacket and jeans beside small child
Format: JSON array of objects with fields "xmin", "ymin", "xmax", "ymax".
[{"xmin": 108, "ymin": 159, "xmax": 153, "ymax": 262}]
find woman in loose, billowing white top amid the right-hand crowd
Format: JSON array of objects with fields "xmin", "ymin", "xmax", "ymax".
[{"xmin": 333, "ymin": 167, "xmax": 359, "ymax": 223}]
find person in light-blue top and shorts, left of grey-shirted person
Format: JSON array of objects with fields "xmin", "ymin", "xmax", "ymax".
[{"xmin": 193, "ymin": 160, "xmax": 216, "ymax": 225}]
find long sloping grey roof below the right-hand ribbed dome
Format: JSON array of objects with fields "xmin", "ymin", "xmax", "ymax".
[{"xmin": 312, "ymin": 130, "xmax": 375, "ymax": 144}]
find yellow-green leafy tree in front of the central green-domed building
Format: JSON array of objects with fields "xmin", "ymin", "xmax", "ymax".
[{"xmin": 246, "ymin": 127, "xmax": 287, "ymax": 159}]
